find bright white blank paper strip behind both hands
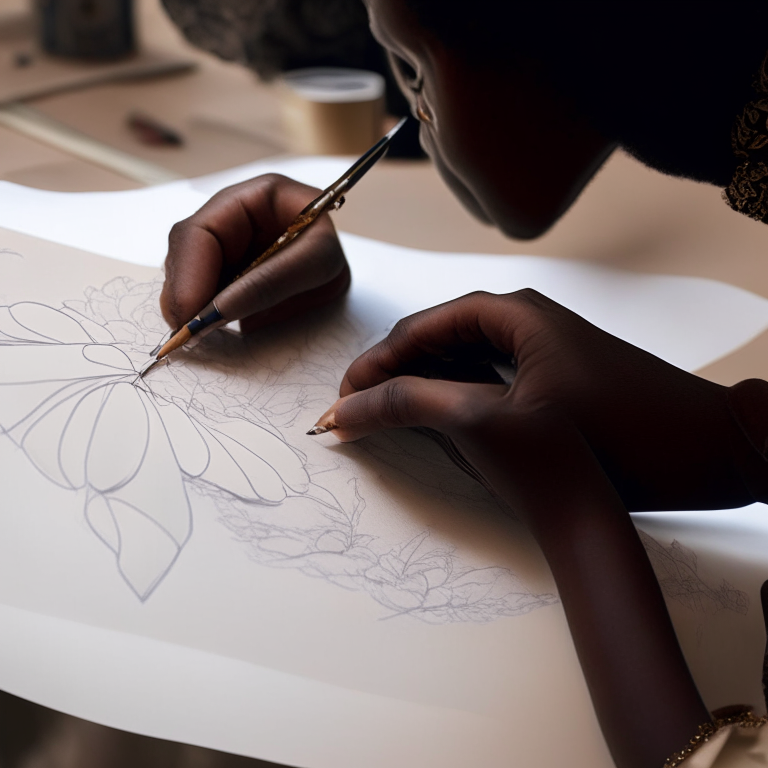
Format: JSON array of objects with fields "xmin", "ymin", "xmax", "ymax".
[{"xmin": 0, "ymin": 152, "xmax": 766, "ymax": 370}]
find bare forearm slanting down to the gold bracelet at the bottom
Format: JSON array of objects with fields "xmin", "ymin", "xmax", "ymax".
[{"xmin": 467, "ymin": 415, "xmax": 710, "ymax": 768}]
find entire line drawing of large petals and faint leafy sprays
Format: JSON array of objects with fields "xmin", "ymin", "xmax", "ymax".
[{"xmin": 0, "ymin": 277, "xmax": 557, "ymax": 623}]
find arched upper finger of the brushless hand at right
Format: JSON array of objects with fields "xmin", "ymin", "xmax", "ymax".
[{"xmin": 340, "ymin": 289, "xmax": 568, "ymax": 395}]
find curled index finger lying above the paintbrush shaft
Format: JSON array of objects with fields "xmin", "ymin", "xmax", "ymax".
[{"xmin": 161, "ymin": 174, "xmax": 340, "ymax": 326}]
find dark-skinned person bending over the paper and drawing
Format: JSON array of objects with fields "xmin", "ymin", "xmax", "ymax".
[{"xmin": 161, "ymin": 0, "xmax": 768, "ymax": 768}]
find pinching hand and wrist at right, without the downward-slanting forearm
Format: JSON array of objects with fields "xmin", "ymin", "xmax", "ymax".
[{"xmin": 319, "ymin": 290, "xmax": 755, "ymax": 511}]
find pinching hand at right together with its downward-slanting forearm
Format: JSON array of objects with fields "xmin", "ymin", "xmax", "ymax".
[{"xmin": 308, "ymin": 290, "xmax": 759, "ymax": 768}]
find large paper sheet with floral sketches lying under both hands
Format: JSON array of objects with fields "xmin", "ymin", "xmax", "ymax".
[{"xmin": 0, "ymin": 164, "xmax": 768, "ymax": 768}]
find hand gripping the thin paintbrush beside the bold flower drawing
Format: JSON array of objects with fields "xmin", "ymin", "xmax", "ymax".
[{"xmin": 160, "ymin": 174, "xmax": 350, "ymax": 331}]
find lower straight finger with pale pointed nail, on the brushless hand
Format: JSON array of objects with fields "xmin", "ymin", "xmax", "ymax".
[{"xmin": 310, "ymin": 376, "xmax": 508, "ymax": 442}]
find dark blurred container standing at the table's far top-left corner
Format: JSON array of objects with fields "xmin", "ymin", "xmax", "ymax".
[{"xmin": 38, "ymin": 0, "xmax": 135, "ymax": 60}]
